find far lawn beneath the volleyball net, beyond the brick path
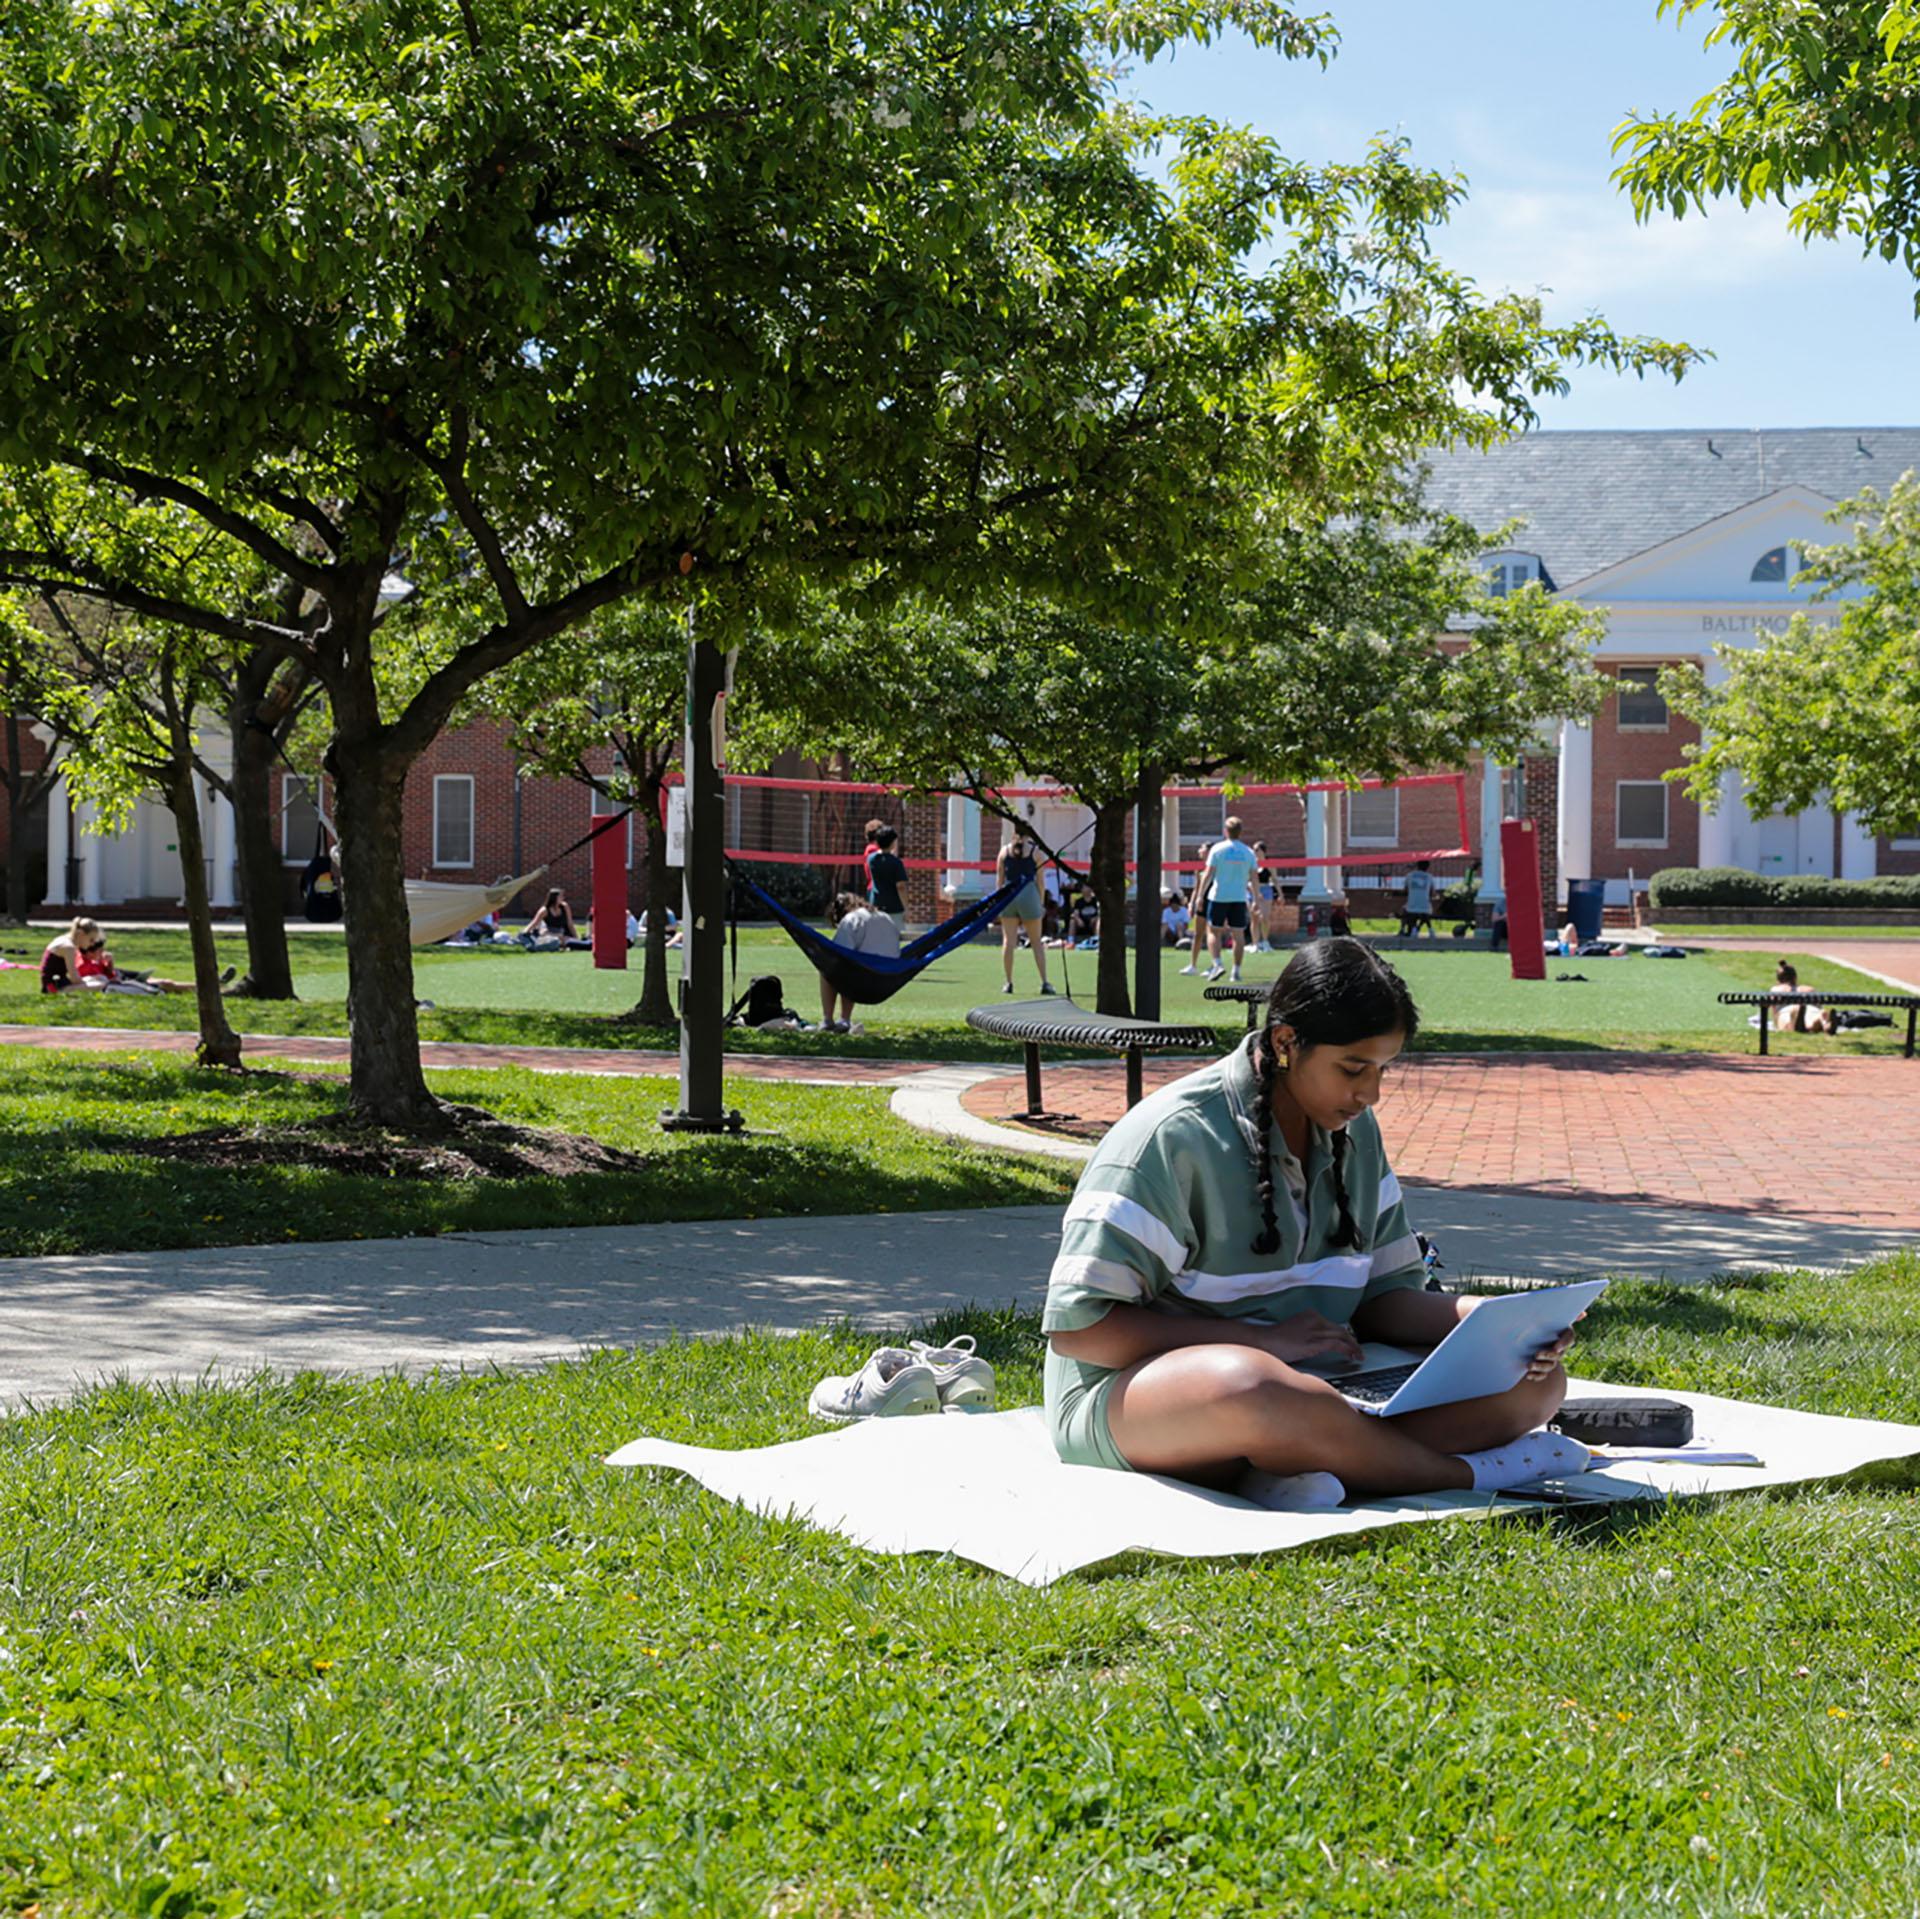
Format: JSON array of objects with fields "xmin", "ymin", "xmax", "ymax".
[{"xmin": 0, "ymin": 930, "xmax": 1905, "ymax": 1060}]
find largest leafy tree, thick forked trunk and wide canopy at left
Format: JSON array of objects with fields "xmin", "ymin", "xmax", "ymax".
[{"xmin": 0, "ymin": 0, "xmax": 1686, "ymax": 1128}]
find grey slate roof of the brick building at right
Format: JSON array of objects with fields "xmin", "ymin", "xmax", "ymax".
[{"xmin": 1427, "ymin": 426, "xmax": 1920, "ymax": 588}]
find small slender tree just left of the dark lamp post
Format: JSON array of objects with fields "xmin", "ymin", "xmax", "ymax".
[{"xmin": 472, "ymin": 603, "xmax": 687, "ymax": 1026}]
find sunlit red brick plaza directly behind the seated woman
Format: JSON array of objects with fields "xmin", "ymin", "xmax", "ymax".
[{"xmin": 964, "ymin": 1053, "xmax": 1920, "ymax": 1233}]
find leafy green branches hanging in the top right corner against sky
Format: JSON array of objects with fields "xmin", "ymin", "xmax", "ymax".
[{"xmin": 1615, "ymin": 0, "xmax": 1920, "ymax": 295}]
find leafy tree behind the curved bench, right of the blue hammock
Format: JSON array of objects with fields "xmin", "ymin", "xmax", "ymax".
[{"xmin": 747, "ymin": 524, "xmax": 1603, "ymax": 1012}]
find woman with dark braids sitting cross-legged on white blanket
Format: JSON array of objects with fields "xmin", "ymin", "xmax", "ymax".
[{"xmin": 1043, "ymin": 939, "xmax": 1588, "ymax": 1506}]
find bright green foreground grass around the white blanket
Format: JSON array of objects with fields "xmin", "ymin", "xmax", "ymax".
[{"xmin": 0, "ymin": 1256, "xmax": 1920, "ymax": 1919}]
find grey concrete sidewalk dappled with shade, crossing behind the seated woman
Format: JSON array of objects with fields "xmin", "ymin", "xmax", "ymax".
[{"xmin": 0, "ymin": 1185, "xmax": 1912, "ymax": 1410}]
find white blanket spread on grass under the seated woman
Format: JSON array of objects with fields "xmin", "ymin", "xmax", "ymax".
[{"xmin": 607, "ymin": 1381, "xmax": 1920, "ymax": 1587}]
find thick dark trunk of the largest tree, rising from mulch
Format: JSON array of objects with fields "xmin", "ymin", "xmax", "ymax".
[{"xmin": 326, "ymin": 729, "xmax": 447, "ymax": 1133}]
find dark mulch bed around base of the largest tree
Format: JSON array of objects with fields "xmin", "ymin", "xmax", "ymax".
[{"xmin": 123, "ymin": 1106, "xmax": 647, "ymax": 1179}]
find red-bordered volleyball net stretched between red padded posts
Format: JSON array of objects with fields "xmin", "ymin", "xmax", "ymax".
[{"xmin": 702, "ymin": 772, "xmax": 1473, "ymax": 891}]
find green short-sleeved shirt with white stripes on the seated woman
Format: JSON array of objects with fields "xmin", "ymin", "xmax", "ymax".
[{"xmin": 1041, "ymin": 1033, "xmax": 1425, "ymax": 1336}]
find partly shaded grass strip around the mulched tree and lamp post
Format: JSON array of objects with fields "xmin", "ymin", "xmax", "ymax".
[{"xmin": 0, "ymin": 1047, "xmax": 1077, "ymax": 1254}]
